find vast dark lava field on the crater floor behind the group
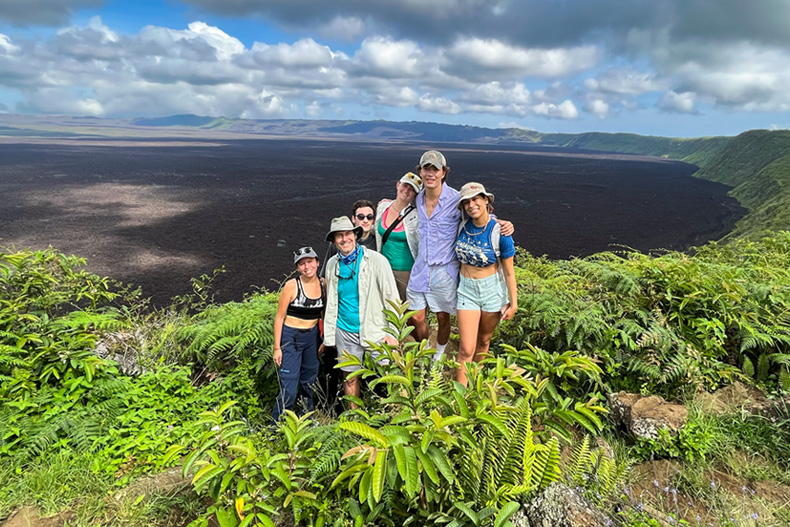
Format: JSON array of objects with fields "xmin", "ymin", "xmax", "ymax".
[{"xmin": 0, "ymin": 139, "xmax": 745, "ymax": 304}]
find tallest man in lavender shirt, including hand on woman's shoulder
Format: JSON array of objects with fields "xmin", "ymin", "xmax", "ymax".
[{"xmin": 406, "ymin": 150, "xmax": 513, "ymax": 360}]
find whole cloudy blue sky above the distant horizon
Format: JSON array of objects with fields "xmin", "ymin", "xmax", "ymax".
[{"xmin": 0, "ymin": 0, "xmax": 790, "ymax": 137}]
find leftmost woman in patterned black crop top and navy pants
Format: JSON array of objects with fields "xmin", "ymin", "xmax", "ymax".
[{"xmin": 273, "ymin": 247, "xmax": 326, "ymax": 421}]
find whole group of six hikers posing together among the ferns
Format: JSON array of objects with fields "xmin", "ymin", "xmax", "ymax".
[{"xmin": 274, "ymin": 150, "xmax": 518, "ymax": 420}]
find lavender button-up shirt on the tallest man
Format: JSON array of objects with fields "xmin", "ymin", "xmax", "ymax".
[{"xmin": 409, "ymin": 185, "xmax": 461, "ymax": 293}]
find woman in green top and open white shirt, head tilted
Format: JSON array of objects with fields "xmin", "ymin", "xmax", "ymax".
[{"xmin": 374, "ymin": 172, "xmax": 422, "ymax": 302}]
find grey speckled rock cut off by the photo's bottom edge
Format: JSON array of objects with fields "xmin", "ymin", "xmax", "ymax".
[{"xmin": 524, "ymin": 483, "xmax": 612, "ymax": 527}]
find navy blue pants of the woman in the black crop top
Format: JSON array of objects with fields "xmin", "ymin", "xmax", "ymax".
[{"xmin": 273, "ymin": 324, "xmax": 321, "ymax": 421}]
